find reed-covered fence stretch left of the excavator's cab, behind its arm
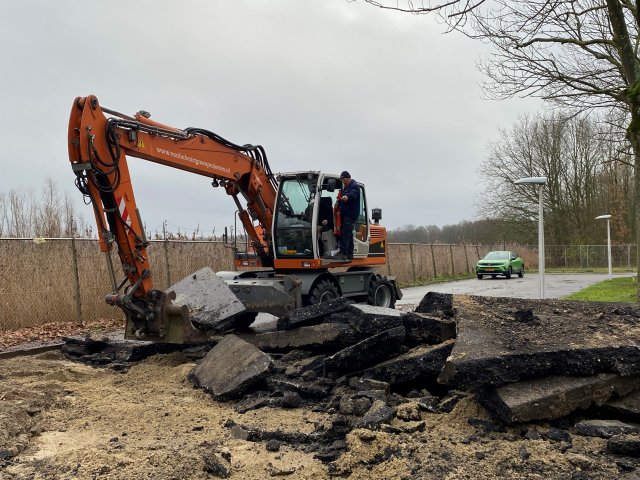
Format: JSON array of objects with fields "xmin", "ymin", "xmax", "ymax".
[{"xmin": 0, "ymin": 238, "xmax": 234, "ymax": 331}]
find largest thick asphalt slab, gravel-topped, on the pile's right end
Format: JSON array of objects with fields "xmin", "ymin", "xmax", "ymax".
[{"xmin": 439, "ymin": 295, "xmax": 640, "ymax": 388}]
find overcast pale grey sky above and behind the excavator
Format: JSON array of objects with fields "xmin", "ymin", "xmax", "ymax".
[{"xmin": 0, "ymin": 0, "xmax": 538, "ymax": 233}]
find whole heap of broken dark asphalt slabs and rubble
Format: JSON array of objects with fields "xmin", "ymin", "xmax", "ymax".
[{"xmin": 65, "ymin": 292, "xmax": 640, "ymax": 471}]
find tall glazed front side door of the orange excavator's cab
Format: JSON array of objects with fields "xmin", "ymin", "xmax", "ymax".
[{"xmin": 275, "ymin": 175, "xmax": 317, "ymax": 258}]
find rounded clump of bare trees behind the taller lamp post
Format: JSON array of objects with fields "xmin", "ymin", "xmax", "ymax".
[{"xmin": 479, "ymin": 112, "xmax": 631, "ymax": 243}]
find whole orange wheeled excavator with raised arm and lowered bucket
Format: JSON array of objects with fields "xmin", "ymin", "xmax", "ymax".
[{"xmin": 68, "ymin": 96, "xmax": 401, "ymax": 342}]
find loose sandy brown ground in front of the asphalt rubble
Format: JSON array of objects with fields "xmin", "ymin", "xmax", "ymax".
[{"xmin": 0, "ymin": 278, "xmax": 640, "ymax": 480}]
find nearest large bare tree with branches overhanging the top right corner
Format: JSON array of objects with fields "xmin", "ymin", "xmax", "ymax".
[{"xmin": 365, "ymin": 0, "xmax": 640, "ymax": 292}]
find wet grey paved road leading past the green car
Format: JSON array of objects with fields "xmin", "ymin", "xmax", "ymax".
[{"xmin": 396, "ymin": 273, "xmax": 633, "ymax": 305}]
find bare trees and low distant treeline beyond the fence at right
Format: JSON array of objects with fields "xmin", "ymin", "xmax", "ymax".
[{"xmin": 389, "ymin": 112, "xmax": 635, "ymax": 245}]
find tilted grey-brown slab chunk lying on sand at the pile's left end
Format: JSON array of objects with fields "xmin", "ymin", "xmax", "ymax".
[{"xmin": 189, "ymin": 335, "xmax": 273, "ymax": 400}]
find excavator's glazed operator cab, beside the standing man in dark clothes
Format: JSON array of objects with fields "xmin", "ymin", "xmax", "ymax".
[{"xmin": 272, "ymin": 172, "xmax": 369, "ymax": 263}]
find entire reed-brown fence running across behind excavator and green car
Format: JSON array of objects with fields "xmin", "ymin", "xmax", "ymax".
[{"xmin": 0, "ymin": 238, "xmax": 636, "ymax": 331}]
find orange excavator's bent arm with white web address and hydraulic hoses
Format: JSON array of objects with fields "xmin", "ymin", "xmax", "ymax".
[{"xmin": 68, "ymin": 96, "xmax": 277, "ymax": 338}]
